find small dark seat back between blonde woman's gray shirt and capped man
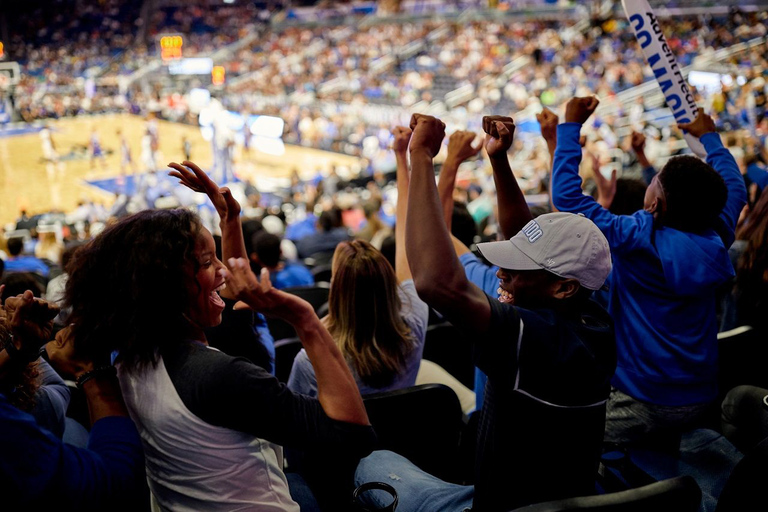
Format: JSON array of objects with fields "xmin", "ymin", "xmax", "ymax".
[{"xmin": 423, "ymin": 322, "xmax": 475, "ymax": 389}]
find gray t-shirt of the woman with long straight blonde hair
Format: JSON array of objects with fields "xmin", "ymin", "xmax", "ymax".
[{"xmin": 288, "ymin": 279, "xmax": 429, "ymax": 397}]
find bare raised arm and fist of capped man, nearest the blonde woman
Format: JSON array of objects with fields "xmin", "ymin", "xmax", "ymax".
[{"xmin": 405, "ymin": 114, "xmax": 491, "ymax": 333}]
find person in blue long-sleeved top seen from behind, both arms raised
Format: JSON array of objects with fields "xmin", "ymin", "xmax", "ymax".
[{"xmin": 552, "ymin": 97, "xmax": 746, "ymax": 447}]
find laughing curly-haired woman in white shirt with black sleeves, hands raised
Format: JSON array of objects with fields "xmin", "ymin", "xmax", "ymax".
[{"xmin": 65, "ymin": 162, "xmax": 374, "ymax": 510}]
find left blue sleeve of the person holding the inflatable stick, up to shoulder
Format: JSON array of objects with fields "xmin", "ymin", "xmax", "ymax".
[{"xmin": 552, "ymin": 123, "xmax": 649, "ymax": 254}]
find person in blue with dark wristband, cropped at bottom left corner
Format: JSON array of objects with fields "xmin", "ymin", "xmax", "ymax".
[{"xmin": 0, "ymin": 292, "xmax": 149, "ymax": 511}]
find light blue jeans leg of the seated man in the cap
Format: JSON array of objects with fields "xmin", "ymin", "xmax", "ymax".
[{"xmin": 355, "ymin": 451, "xmax": 475, "ymax": 512}]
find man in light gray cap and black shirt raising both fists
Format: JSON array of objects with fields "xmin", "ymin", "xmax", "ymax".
[{"xmin": 356, "ymin": 114, "xmax": 615, "ymax": 512}]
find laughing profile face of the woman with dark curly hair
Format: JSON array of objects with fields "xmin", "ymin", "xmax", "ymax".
[{"xmin": 187, "ymin": 228, "xmax": 224, "ymax": 328}]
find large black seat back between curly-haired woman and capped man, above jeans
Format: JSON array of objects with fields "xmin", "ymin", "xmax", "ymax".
[{"xmin": 363, "ymin": 384, "xmax": 464, "ymax": 482}]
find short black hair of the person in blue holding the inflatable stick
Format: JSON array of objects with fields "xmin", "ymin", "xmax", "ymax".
[{"xmin": 659, "ymin": 155, "xmax": 728, "ymax": 233}]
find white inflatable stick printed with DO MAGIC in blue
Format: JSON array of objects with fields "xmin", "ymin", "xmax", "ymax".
[{"xmin": 621, "ymin": 0, "xmax": 707, "ymax": 158}]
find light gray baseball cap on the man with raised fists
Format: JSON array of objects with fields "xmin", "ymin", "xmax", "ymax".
[{"xmin": 477, "ymin": 212, "xmax": 611, "ymax": 290}]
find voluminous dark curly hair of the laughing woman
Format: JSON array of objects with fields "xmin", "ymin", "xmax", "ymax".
[{"xmin": 64, "ymin": 209, "xmax": 202, "ymax": 366}]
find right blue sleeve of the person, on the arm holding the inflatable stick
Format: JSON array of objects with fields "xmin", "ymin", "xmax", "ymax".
[{"xmin": 701, "ymin": 132, "xmax": 747, "ymax": 247}]
